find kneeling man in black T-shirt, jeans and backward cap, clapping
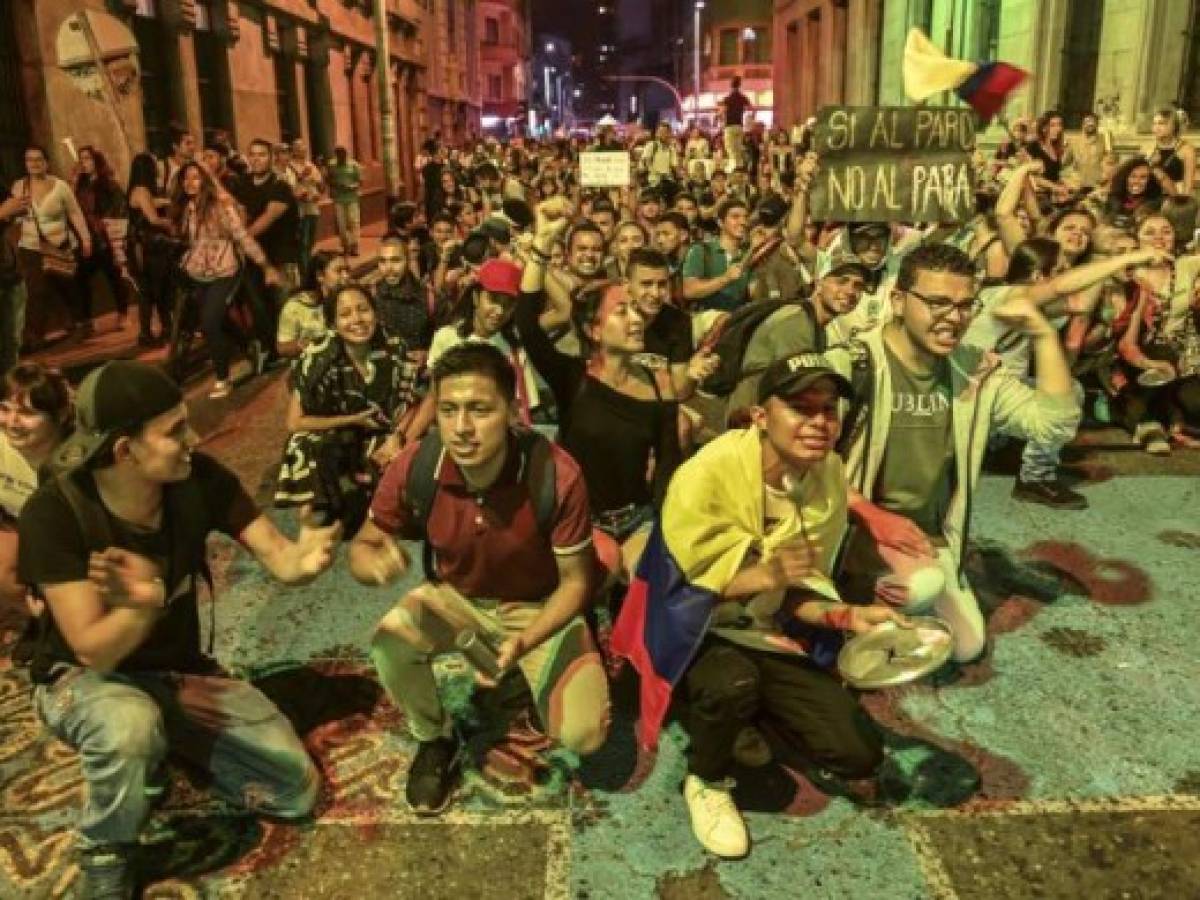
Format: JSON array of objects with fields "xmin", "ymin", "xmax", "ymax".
[{"xmin": 19, "ymin": 360, "xmax": 338, "ymax": 898}]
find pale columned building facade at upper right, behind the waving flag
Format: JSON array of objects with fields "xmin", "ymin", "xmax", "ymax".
[{"xmin": 773, "ymin": 0, "xmax": 1200, "ymax": 145}]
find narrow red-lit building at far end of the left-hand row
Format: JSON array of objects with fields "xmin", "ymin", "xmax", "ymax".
[{"xmin": 479, "ymin": 0, "xmax": 532, "ymax": 134}]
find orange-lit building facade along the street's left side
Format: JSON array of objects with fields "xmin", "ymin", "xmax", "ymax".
[{"xmin": 0, "ymin": 0, "xmax": 480, "ymax": 216}]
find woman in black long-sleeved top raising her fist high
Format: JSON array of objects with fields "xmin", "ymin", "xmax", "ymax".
[{"xmin": 516, "ymin": 211, "xmax": 682, "ymax": 571}]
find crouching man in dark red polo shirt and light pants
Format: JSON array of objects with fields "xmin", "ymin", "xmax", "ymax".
[{"xmin": 349, "ymin": 343, "xmax": 608, "ymax": 815}]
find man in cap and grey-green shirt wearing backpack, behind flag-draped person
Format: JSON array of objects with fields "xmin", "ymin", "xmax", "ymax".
[{"xmin": 728, "ymin": 254, "xmax": 868, "ymax": 415}]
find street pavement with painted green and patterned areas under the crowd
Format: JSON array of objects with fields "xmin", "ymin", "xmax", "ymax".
[{"xmin": 0, "ymin": 376, "xmax": 1200, "ymax": 900}]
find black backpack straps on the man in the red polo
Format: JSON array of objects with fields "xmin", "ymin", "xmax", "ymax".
[{"xmin": 404, "ymin": 428, "xmax": 558, "ymax": 582}]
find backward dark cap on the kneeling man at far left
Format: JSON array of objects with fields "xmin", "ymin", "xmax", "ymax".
[{"xmin": 52, "ymin": 360, "xmax": 184, "ymax": 472}]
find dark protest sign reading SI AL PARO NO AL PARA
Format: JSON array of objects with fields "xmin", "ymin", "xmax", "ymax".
[{"xmin": 809, "ymin": 107, "xmax": 976, "ymax": 222}]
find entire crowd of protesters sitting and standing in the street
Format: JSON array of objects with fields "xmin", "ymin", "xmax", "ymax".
[{"xmin": 0, "ymin": 84, "xmax": 1200, "ymax": 895}]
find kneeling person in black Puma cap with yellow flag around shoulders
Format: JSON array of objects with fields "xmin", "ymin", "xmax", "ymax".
[{"xmin": 650, "ymin": 354, "xmax": 902, "ymax": 858}]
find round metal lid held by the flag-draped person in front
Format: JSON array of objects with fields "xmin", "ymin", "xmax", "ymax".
[{"xmin": 838, "ymin": 616, "xmax": 954, "ymax": 690}]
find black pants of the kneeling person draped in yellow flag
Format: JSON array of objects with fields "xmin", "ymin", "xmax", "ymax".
[{"xmin": 684, "ymin": 636, "xmax": 883, "ymax": 781}]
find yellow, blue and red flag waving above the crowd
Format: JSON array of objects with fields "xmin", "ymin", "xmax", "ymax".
[{"xmin": 904, "ymin": 28, "xmax": 1028, "ymax": 122}]
